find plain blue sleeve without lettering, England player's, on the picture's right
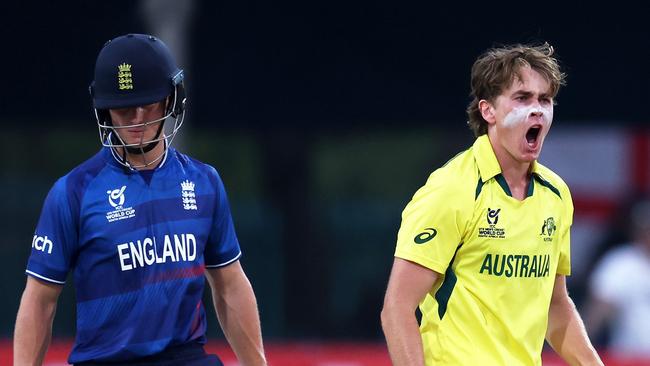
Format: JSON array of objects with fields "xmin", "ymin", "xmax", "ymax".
[{"xmin": 205, "ymin": 167, "xmax": 241, "ymax": 268}]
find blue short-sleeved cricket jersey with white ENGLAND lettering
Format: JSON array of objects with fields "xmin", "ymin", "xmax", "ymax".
[{"xmin": 26, "ymin": 148, "xmax": 241, "ymax": 363}]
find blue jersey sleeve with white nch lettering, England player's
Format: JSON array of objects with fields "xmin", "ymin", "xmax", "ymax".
[{"xmin": 25, "ymin": 178, "xmax": 77, "ymax": 284}]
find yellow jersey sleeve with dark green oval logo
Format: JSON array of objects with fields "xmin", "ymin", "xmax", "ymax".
[{"xmin": 395, "ymin": 172, "xmax": 473, "ymax": 274}]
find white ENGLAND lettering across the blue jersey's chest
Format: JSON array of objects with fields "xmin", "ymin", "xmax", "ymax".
[{"xmin": 117, "ymin": 233, "xmax": 196, "ymax": 271}]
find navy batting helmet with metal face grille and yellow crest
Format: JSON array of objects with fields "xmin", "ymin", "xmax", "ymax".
[{"xmin": 90, "ymin": 34, "xmax": 186, "ymax": 168}]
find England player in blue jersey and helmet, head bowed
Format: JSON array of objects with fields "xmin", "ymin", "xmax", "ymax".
[{"xmin": 14, "ymin": 34, "xmax": 266, "ymax": 366}]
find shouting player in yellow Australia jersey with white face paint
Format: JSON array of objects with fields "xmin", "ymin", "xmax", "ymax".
[{"xmin": 381, "ymin": 44, "xmax": 602, "ymax": 366}]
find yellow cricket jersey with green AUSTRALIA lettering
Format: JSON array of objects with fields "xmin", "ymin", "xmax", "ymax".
[{"xmin": 395, "ymin": 135, "xmax": 573, "ymax": 365}]
